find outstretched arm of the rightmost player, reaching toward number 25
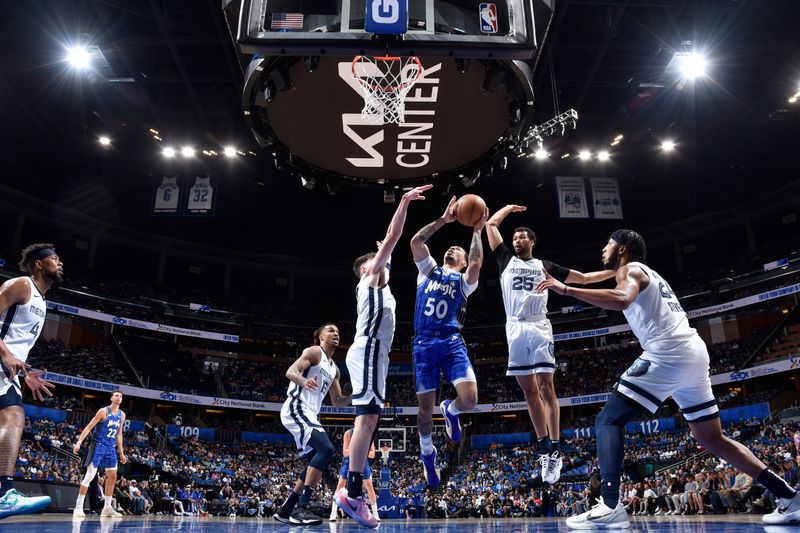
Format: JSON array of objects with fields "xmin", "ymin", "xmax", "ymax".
[{"xmin": 536, "ymin": 265, "xmax": 648, "ymax": 311}]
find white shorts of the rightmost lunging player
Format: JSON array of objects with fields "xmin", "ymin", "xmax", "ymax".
[{"xmin": 616, "ymin": 335, "xmax": 719, "ymax": 422}]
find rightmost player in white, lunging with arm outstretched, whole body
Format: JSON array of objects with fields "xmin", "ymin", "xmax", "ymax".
[{"xmin": 537, "ymin": 229, "xmax": 800, "ymax": 529}]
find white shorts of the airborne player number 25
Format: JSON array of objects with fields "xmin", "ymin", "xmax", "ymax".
[{"xmin": 506, "ymin": 318, "xmax": 556, "ymax": 376}]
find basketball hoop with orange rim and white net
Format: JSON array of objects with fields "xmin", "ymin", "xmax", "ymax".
[{"xmin": 353, "ymin": 56, "xmax": 423, "ymax": 124}]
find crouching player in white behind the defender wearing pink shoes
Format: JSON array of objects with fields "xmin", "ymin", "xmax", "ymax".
[{"xmin": 272, "ymin": 323, "xmax": 352, "ymax": 525}]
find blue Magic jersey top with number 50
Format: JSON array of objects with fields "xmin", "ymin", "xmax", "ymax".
[{"xmin": 414, "ymin": 256, "xmax": 475, "ymax": 336}]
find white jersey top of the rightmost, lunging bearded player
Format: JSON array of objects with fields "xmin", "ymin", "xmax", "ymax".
[{"xmin": 623, "ymin": 263, "xmax": 697, "ymax": 353}]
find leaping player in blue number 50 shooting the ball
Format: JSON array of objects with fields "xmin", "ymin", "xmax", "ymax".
[{"xmin": 411, "ymin": 196, "xmax": 489, "ymax": 487}]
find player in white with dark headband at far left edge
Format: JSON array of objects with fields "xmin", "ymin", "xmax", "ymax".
[{"xmin": 0, "ymin": 243, "xmax": 64, "ymax": 518}]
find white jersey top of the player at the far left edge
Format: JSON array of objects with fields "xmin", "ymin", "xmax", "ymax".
[{"xmin": 0, "ymin": 278, "xmax": 47, "ymax": 361}]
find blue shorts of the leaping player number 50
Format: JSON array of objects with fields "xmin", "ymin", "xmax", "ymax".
[{"xmin": 413, "ymin": 333, "xmax": 477, "ymax": 394}]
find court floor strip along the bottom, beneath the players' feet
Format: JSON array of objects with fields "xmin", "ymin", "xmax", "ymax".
[{"xmin": 0, "ymin": 514, "xmax": 788, "ymax": 533}]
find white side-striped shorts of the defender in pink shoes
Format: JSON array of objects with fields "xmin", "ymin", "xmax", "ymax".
[{"xmin": 345, "ymin": 337, "xmax": 389, "ymax": 407}]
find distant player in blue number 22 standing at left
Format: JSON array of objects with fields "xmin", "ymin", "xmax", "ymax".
[{"xmin": 72, "ymin": 390, "xmax": 128, "ymax": 516}]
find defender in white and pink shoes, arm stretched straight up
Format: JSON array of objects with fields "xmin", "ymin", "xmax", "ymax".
[{"xmin": 334, "ymin": 185, "xmax": 432, "ymax": 527}]
